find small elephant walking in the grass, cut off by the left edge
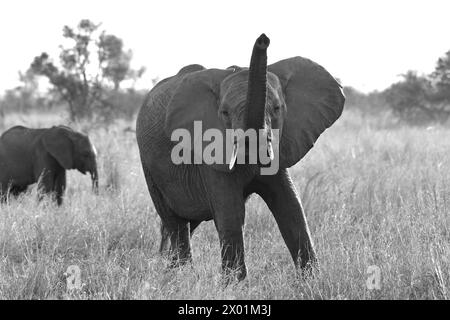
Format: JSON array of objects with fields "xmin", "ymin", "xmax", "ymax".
[{"xmin": 0, "ymin": 126, "xmax": 98, "ymax": 205}]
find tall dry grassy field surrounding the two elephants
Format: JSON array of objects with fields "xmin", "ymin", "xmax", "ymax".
[{"xmin": 0, "ymin": 111, "xmax": 450, "ymax": 299}]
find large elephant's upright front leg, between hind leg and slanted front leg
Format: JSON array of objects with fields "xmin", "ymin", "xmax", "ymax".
[{"xmin": 203, "ymin": 169, "xmax": 247, "ymax": 281}]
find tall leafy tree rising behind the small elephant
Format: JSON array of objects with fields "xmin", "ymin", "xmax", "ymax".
[{"xmin": 30, "ymin": 19, "xmax": 143, "ymax": 121}]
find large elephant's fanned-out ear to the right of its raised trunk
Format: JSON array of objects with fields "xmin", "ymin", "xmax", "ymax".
[{"xmin": 268, "ymin": 57, "xmax": 345, "ymax": 168}]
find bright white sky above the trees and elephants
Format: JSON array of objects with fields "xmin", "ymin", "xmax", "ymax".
[{"xmin": 0, "ymin": 0, "xmax": 450, "ymax": 92}]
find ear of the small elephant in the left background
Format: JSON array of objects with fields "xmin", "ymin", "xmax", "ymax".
[{"xmin": 42, "ymin": 127, "xmax": 73, "ymax": 169}]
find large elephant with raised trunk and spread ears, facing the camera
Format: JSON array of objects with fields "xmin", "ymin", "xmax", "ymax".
[{"xmin": 136, "ymin": 34, "xmax": 345, "ymax": 280}]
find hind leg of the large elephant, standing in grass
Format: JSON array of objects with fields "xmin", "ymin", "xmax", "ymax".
[{"xmin": 143, "ymin": 166, "xmax": 192, "ymax": 266}]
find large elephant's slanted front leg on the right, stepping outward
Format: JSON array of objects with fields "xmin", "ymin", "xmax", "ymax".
[{"xmin": 257, "ymin": 169, "xmax": 316, "ymax": 272}]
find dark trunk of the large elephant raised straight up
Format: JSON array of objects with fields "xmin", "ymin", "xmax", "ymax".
[{"xmin": 245, "ymin": 33, "xmax": 270, "ymax": 130}]
